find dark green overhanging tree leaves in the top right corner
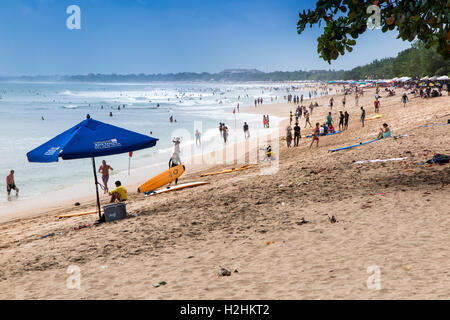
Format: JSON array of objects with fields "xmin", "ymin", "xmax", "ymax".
[{"xmin": 297, "ymin": 0, "xmax": 450, "ymax": 63}]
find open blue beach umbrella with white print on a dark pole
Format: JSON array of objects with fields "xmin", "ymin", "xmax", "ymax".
[{"xmin": 27, "ymin": 118, "xmax": 158, "ymax": 218}]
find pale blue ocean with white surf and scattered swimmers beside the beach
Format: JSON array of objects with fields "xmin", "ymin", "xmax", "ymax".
[{"xmin": 0, "ymin": 82, "xmax": 314, "ymax": 212}]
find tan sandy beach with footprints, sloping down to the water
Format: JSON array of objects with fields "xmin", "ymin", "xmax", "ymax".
[{"xmin": 0, "ymin": 89, "xmax": 450, "ymax": 299}]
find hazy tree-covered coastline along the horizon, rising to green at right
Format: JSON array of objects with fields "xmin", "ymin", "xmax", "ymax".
[{"xmin": 0, "ymin": 42, "xmax": 450, "ymax": 83}]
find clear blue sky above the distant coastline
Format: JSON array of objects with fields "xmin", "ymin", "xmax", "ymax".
[{"xmin": 0, "ymin": 0, "xmax": 410, "ymax": 76}]
